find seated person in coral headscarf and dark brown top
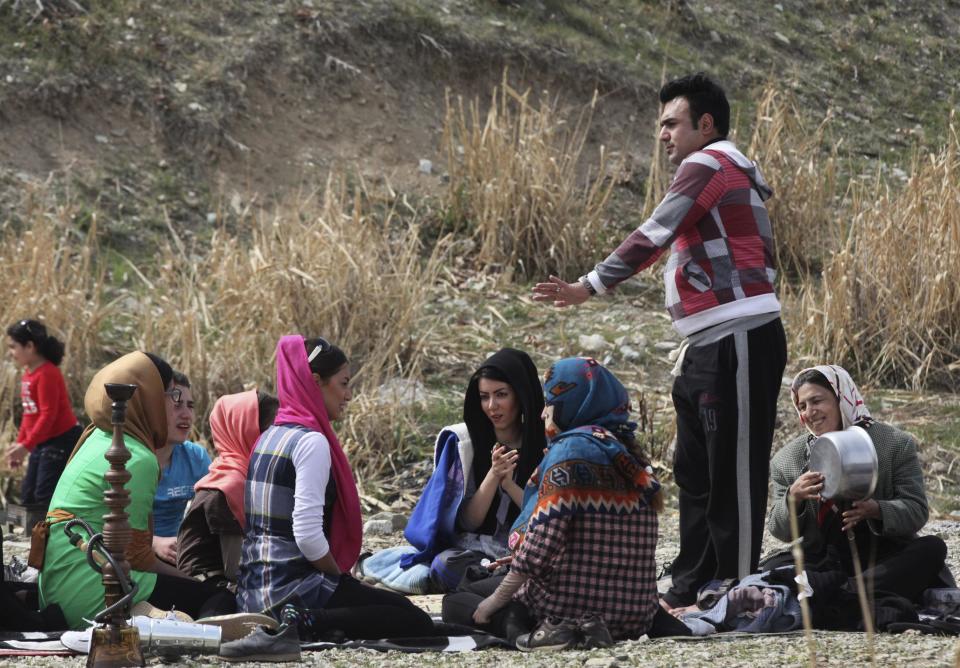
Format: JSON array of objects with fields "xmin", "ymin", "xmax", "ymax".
[{"xmin": 177, "ymin": 390, "xmax": 279, "ymax": 585}]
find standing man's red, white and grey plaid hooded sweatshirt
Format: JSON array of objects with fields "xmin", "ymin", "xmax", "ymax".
[{"xmin": 587, "ymin": 140, "xmax": 780, "ymax": 336}]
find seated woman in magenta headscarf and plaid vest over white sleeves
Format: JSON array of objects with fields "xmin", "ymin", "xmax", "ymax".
[{"xmin": 237, "ymin": 336, "xmax": 433, "ymax": 639}]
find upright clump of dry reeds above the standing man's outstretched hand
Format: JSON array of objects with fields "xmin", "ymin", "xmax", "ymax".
[{"xmin": 443, "ymin": 71, "xmax": 615, "ymax": 278}]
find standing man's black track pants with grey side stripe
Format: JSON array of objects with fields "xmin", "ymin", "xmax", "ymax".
[{"xmin": 665, "ymin": 318, "xmax": 787, "ymax": 606}]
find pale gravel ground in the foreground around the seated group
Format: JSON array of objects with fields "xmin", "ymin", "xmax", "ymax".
[{"xmin": 7, "ymin": 507, "xmax": 960, "ymax": 668}]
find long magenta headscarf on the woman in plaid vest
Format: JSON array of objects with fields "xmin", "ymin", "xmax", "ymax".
[{"xmin": 273, "ymin": 334, "xmax": 363, "ymax": 572}]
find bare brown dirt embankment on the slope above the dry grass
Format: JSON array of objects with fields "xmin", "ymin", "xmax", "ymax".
[{"xmin": 0, "ymin": 13, "xmax": 655, "ymax": 235}]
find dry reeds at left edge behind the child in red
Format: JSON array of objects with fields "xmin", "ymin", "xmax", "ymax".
[{"xmin": 0, "ymin": 190, "xmax": 109, "ymax": 456}]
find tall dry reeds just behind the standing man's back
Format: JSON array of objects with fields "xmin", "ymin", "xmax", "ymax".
[{"xmin": 747, "ymin": 84, "xmax": 839, "ymax": 276}]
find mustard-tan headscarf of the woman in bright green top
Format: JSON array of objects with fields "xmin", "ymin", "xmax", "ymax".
[{"xmin": 70, "ymin": 352, "xmax": 167, "ymax": 571}]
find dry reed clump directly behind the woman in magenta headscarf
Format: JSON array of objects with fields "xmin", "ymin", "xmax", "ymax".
[{"xmin": 125, "ymin": 176, "xmax": 446, "ymax": 482}]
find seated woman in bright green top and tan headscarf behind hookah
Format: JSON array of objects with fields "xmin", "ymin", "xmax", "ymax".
[{"xmin": 39, "ymin": 352, "xmax": 235, "ymax": 628}]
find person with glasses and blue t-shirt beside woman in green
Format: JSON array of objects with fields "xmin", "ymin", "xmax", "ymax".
[{"xmin": 153, "ymin": 371, "xmax": 210, "ymax": 564}]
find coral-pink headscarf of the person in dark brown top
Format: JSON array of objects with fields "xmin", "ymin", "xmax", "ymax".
[{"xmin": 193, "ymin": 390, "xmax": 260, "ymax": 527}]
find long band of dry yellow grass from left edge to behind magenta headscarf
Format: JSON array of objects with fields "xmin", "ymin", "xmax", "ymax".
[{"xmin": 0, "ymin": 176, "xmax": 446, "ymax": 485}]
